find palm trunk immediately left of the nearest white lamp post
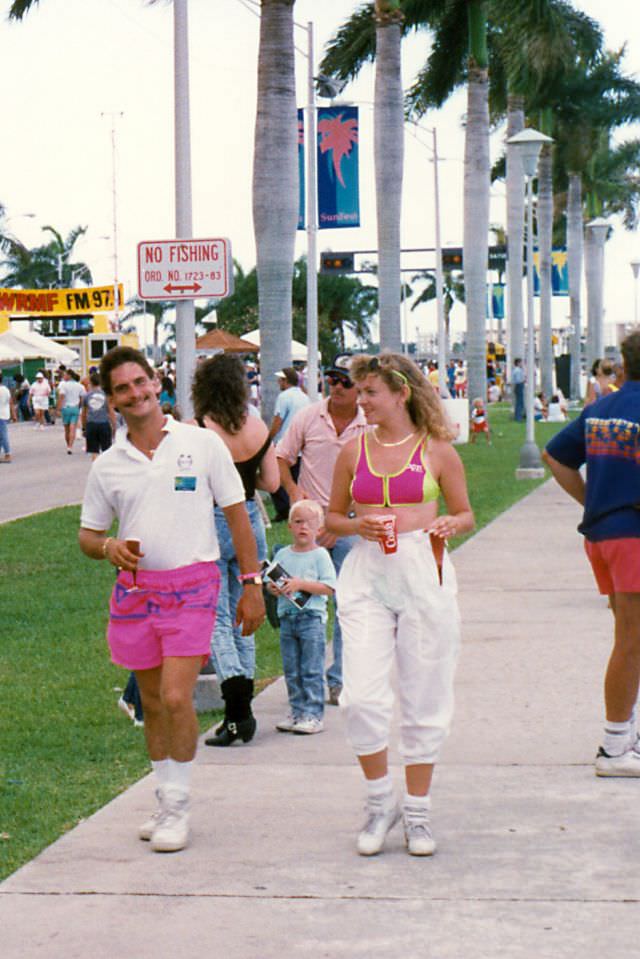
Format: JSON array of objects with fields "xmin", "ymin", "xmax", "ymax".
[{"xmin": 506, "ymin": 94, "xmax": 524, "ymax": 382}]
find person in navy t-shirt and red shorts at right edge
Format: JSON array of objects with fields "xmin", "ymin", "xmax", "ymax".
[{"xmin": 543, "ymin": 332, "xmax": 640, "ymax": 776}]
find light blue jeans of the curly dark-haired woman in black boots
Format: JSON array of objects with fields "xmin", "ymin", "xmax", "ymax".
[{"xmin": 211, "ymin": 500, "xmax": 267, "ymax": 683}]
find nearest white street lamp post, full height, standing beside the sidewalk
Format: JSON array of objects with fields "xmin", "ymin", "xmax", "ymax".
[{"xmin": 507, "ymin": 128, "xmax": 552, "ymax": 479}]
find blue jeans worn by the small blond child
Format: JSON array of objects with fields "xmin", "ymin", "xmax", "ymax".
[{"xmin": 280, "ymin": 610, "xmax": 327, "ymax": 719}]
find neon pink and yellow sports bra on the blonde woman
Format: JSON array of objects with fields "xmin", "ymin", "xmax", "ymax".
[{"xmin": 351, "ymin": 433, "xmax": 440, "ymax": 507}]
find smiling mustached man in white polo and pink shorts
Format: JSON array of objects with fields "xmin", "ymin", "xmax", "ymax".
[{"xmin": 79, "ymin": 347, "xmax": 264, "ymax": 852}]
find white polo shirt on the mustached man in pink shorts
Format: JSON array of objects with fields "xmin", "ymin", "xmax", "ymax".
[{"xmin": 80, "ymin": 416, "xmax": 244, "ymax": 569}]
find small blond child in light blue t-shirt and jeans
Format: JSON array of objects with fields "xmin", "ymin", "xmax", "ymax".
[{"xmin": 267, "ymin": 499, "xmax": 336, "ymax": 735}]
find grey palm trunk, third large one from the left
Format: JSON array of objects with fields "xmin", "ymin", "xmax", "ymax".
[{"xmin": 464, "ymin": 61, "xmax": 490, "ymax": 401}]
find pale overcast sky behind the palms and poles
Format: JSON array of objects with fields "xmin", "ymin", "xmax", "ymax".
[{"xmin": 0, "ymin": 0, "xmax": 640, "ymax": 348}]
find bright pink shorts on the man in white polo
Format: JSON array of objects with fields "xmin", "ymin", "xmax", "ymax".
[{"xmin": 107, "ymin": 563, "xmax": 220, "ymax": 670}]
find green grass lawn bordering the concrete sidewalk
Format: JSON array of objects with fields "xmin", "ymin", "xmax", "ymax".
[{"xmin": 0, "ymin": 405, "xmax": 558, "ymax": 878}]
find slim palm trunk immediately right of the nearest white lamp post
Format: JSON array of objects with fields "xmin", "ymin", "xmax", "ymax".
[{"xmin": 538, "ymin": 146, "xmax": 553, "ymax": 398}]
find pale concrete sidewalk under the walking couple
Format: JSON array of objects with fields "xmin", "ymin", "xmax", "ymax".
[{"xmin": 0, "ymin": 483, "xmax": 640, "ymax": 959}]
